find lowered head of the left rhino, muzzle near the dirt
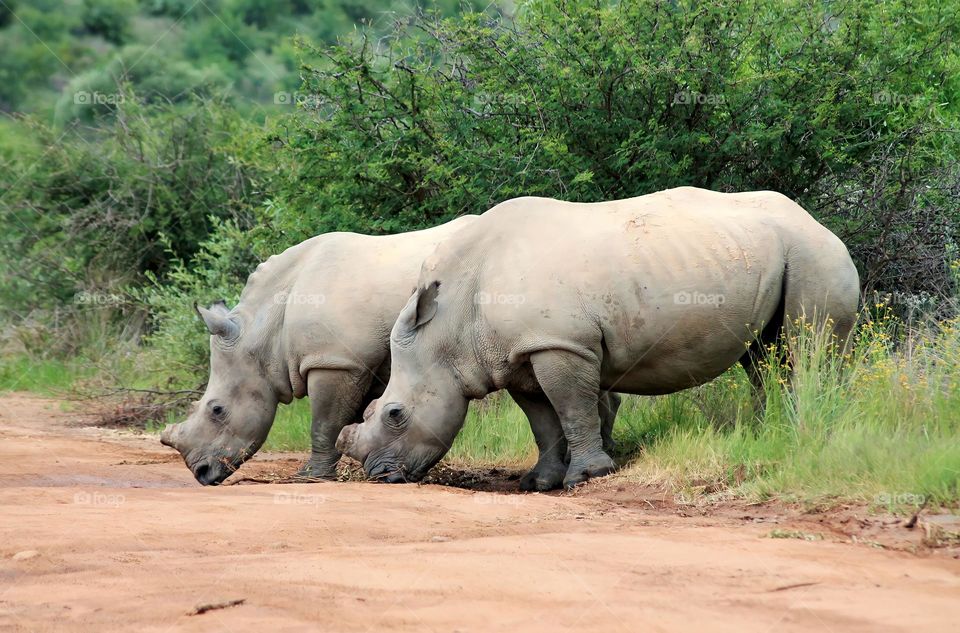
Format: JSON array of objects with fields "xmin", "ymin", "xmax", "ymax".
[{"xmin": 160, "ymin": 302, "xmax": 278, "ymax": 486}]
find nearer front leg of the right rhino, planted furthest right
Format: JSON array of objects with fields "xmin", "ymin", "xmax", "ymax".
[{"xmin": 530, "ymin": 350, "xmax": 616, "ymax": 488}]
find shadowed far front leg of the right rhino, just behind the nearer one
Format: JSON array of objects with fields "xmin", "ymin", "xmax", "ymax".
[{"xmin": 510, "ymin": 390, "xmax": 567, "ymax": 491}]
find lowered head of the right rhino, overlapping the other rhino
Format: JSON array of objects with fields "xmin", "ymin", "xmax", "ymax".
[{"xmin": 337, "ymin": 282, "xmax": 468, "ymax": 483}]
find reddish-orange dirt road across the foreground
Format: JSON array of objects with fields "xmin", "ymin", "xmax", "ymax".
[{"xmin": 0, "ymin": 395, "xmax": 960, "ymax": 633}]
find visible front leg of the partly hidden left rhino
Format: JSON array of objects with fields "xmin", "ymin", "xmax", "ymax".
[{"xmin": 297, "ymin": 369, "xmax": 372, "ymax": 479}]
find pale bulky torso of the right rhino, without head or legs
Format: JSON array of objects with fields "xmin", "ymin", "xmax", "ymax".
[{"xmin": 412, "ymin": 188, "xmax": 855, "ymax": 393}]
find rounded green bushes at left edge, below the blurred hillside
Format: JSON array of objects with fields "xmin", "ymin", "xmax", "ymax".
[{"xmin": 0, "ymin": 92, "xmax": 264, "ymax": 317}]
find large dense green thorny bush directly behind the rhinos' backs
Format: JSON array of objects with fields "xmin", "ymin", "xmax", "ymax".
[{"xmin": 278, "ymin": 0, "xmax": 960, "ymax": 293}]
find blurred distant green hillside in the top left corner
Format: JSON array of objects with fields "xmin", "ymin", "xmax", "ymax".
[{"xmin": 0, "ymin": 0, "xmax": 476, "ymax": 115}]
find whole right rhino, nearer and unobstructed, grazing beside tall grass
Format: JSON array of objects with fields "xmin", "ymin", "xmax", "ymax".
[{"xmin": 337, "ymin": 187, "xmax": 859, "ymax": 489}]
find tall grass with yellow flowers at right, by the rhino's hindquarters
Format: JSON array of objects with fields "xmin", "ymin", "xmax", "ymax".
[{"xmin": 618, "ymin": 310, "xmax": 960, "ymax": 507}]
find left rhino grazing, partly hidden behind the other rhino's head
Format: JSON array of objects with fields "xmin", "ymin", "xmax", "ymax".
[{"xmin": 161, "ymin": 216, "xmax": 476, "ymax": 485}]
